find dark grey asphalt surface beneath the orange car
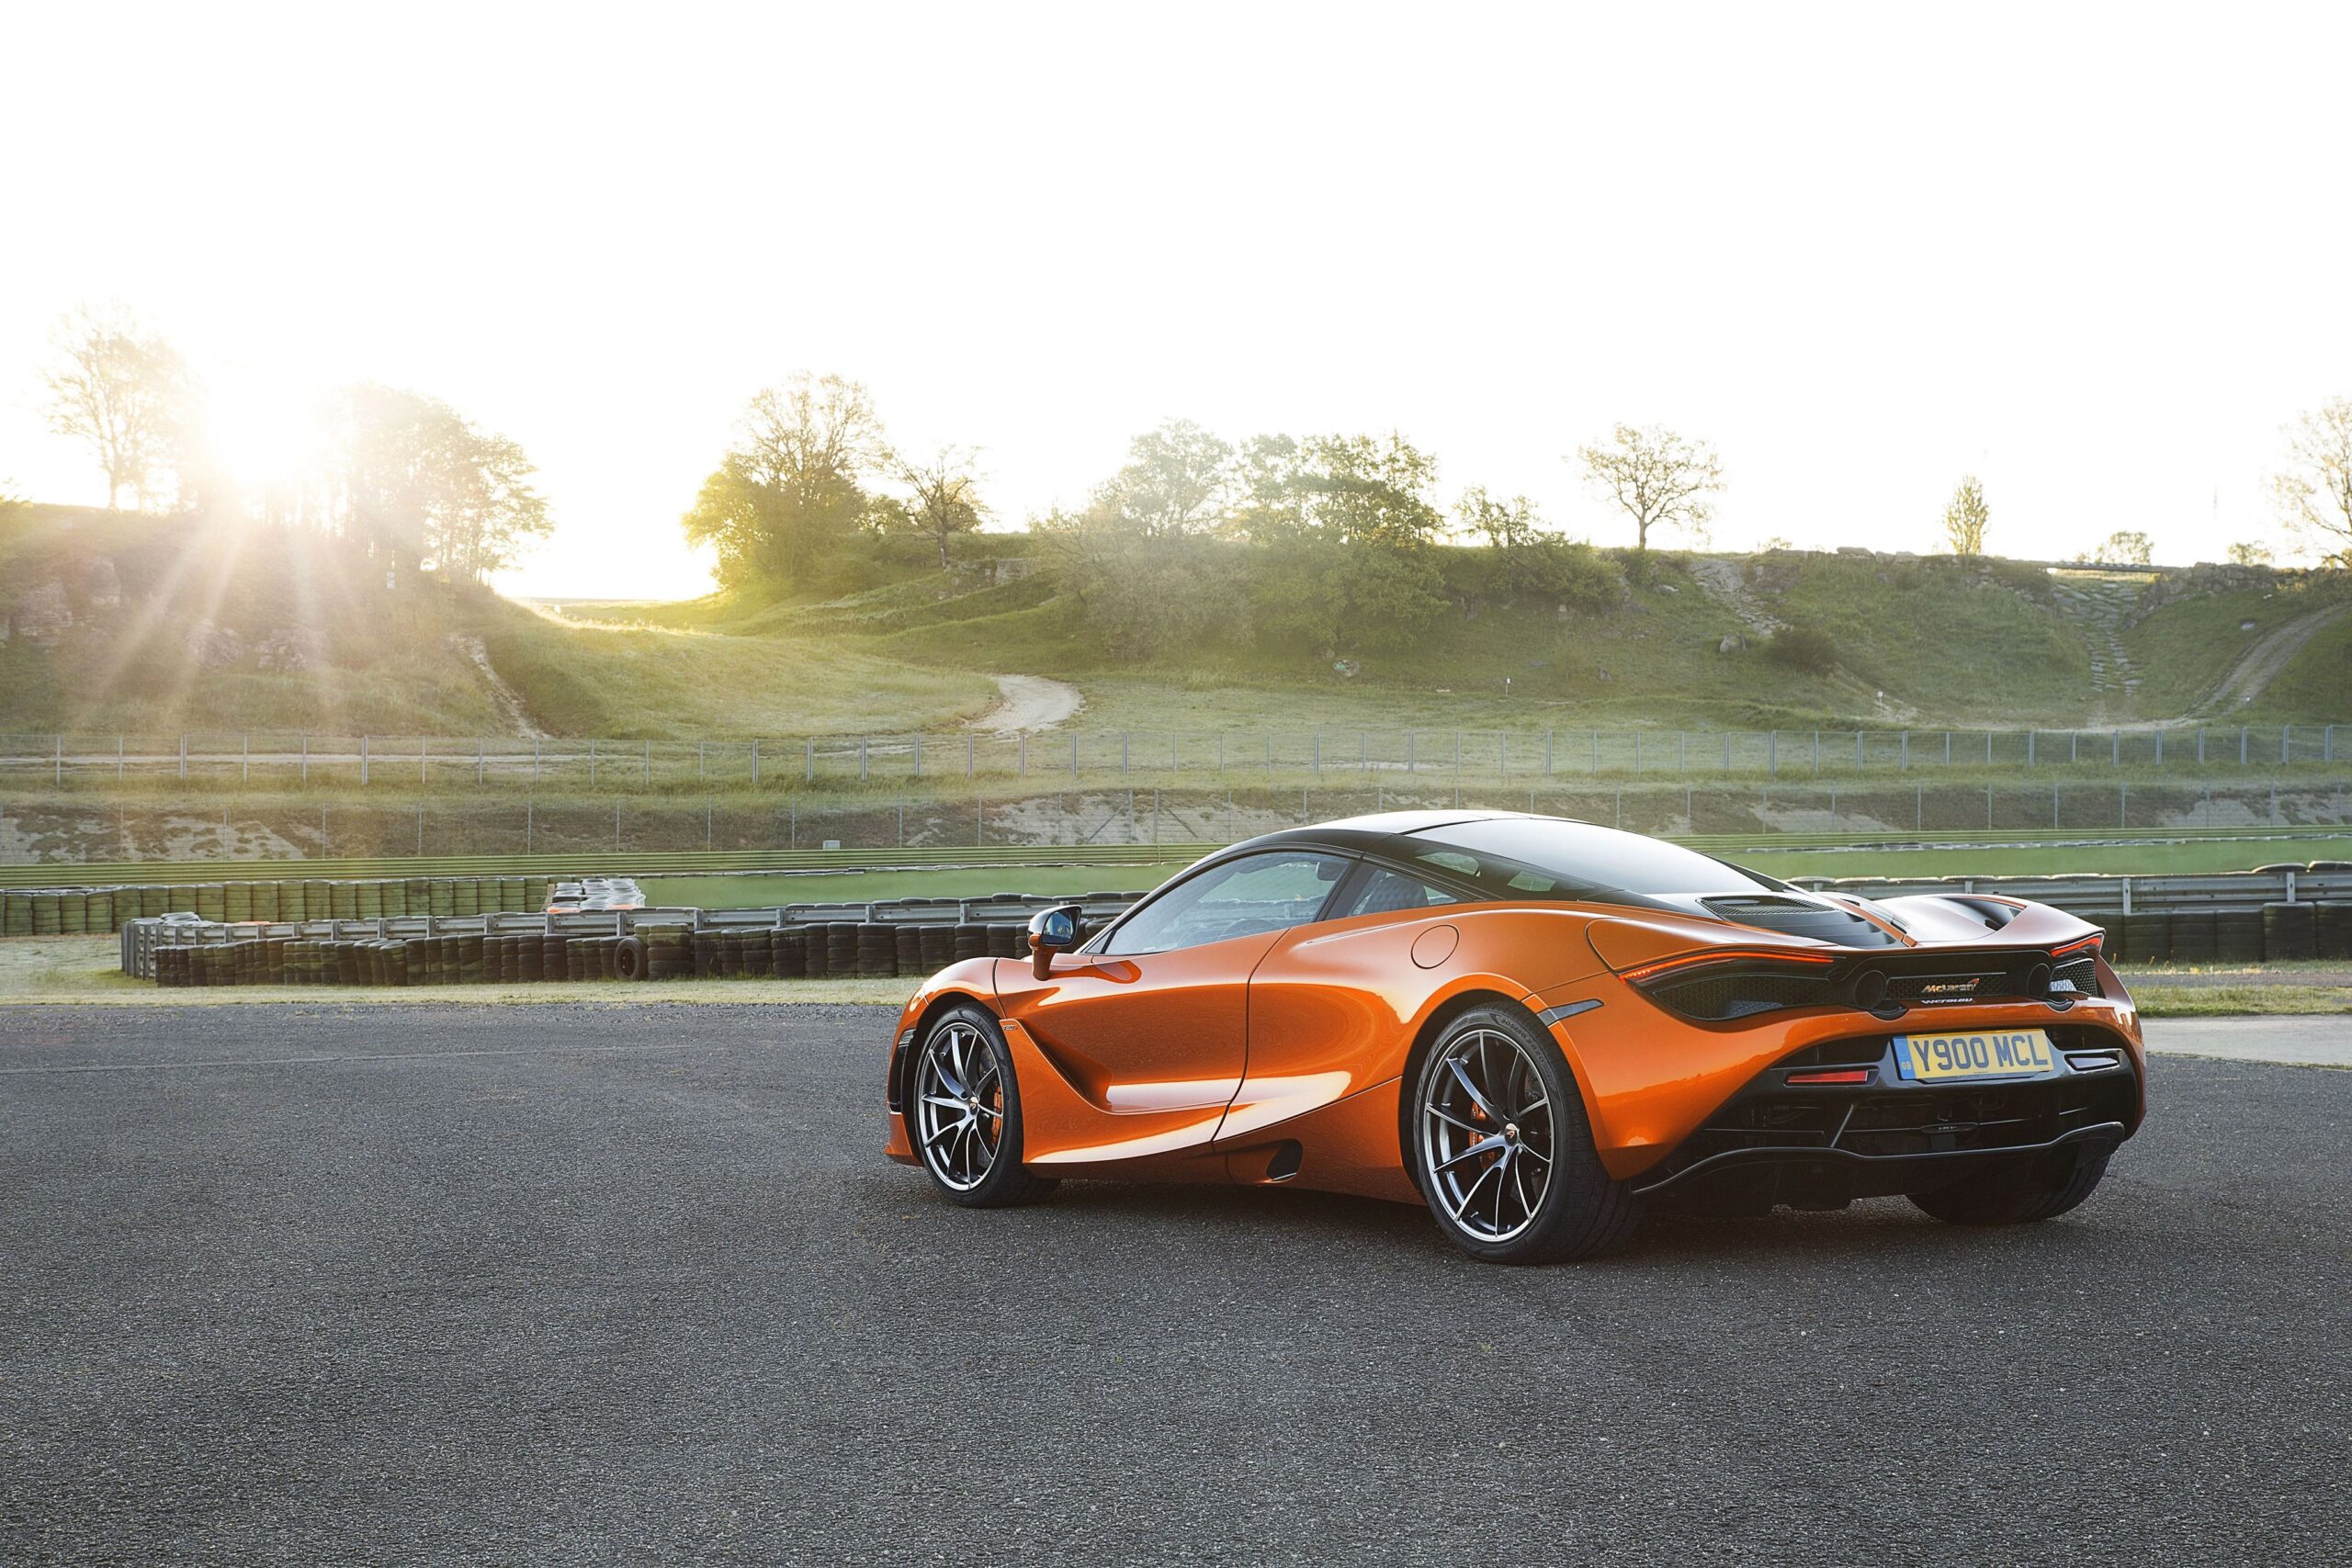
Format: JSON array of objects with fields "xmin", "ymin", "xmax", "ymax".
[{"xmin": 0, "ymin": 1004, "xmax": 2352, "ymax": 1565}]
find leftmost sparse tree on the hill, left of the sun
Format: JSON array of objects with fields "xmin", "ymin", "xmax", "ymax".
[{"xmin": 42, "ymin": 303, "xmax": 186, "ymax": 510}]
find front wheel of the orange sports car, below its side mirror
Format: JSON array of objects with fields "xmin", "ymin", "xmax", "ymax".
[{"xmin": 908, "ymin": 1006, "xmax": 1056, "ymax": 1208}]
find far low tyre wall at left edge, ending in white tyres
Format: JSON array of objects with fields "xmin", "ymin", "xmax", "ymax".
[{"xmin": 0, "ymin": 877, "xmax": 555, "ymax": 936}]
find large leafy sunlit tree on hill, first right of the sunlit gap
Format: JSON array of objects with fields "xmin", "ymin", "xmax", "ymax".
[{"xmin": 682, "ymin": 371, "xmax": 889, "ymax": 583}]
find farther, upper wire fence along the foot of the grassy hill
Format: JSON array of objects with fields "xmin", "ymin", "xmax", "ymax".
[{"xmin": 0, "ymin": 724, "xmax": 2338, "ymax": 792}]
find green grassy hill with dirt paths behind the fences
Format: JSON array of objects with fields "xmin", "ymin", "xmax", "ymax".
[{"xmin": 0, "ymin": 508, "xmax": 2352, "ymax": 739}]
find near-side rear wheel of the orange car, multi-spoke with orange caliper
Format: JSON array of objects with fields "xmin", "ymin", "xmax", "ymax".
[{"xmin": 1411, "ymin": 1006, "xmax": 1639, "ymax": 1262}]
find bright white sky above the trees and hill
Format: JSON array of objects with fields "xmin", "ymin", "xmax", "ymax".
[{"xmin": 0, "ymin": 0, "xmax": 2352, "ymax": 597}]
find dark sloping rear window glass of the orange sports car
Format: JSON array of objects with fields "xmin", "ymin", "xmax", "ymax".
[{"xmin": 1399, "ymin": 816, "xmax": 1781, "ymax": 903}]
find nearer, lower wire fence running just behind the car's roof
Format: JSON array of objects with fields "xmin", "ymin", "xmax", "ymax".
[{"xmin": 0, "ymin": 778, "xmax": 2352, "ymax": 865}]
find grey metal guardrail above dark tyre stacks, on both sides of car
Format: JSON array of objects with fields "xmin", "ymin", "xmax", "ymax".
[{"xmin": 122, "ymin": 867, "xmax": 2352, "ymax": 980}]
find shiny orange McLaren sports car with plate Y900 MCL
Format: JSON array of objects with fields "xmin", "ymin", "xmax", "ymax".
[{"xmin": 887, "ymin": 811, "xmax": 2145, "ymax": 1262}]
